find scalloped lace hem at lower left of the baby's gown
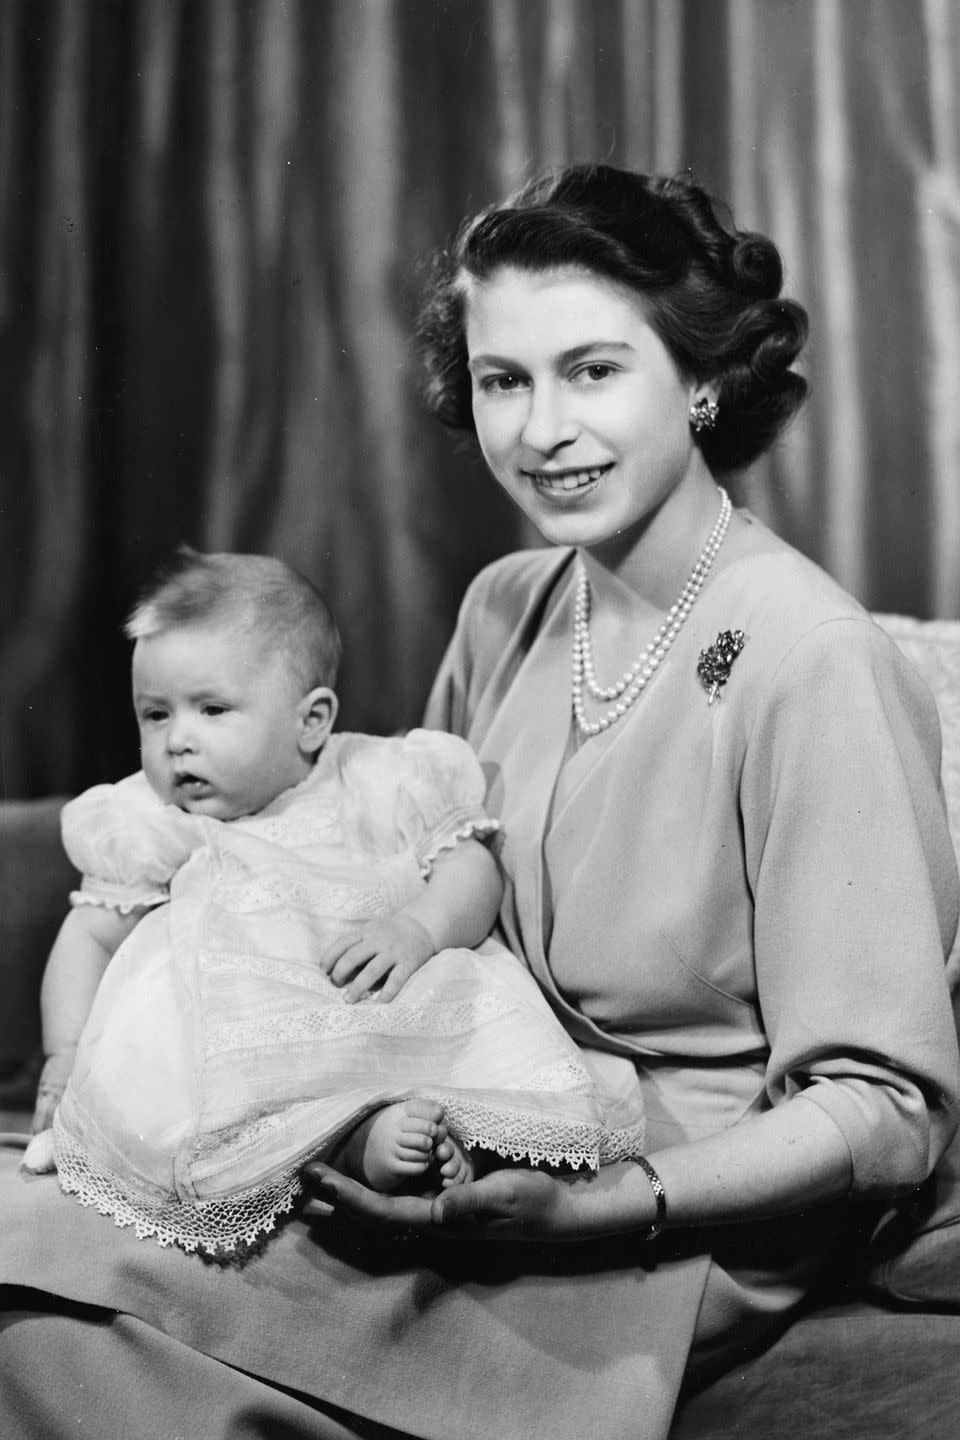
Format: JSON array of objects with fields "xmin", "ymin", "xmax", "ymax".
[{"xmin": 55, "ymin": 1126, "xmax": 302, "ymax": 1259}]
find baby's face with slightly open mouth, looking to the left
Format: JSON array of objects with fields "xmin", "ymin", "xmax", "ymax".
[{"xmin": 132, "ymin": 626, "xmax": 312, "ymax": 819}]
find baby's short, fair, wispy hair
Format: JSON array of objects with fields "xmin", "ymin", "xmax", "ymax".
[{"xmin": 124, "ymin": 546, "xmax": 341, "ymax": 694}]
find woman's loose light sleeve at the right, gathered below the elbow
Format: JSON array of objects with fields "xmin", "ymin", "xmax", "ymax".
[{"xmin": 740, "ymin": 618, "xmax": 960, "ymax": 1192}]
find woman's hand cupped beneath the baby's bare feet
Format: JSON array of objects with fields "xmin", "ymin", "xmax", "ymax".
[{"xmin": 302, "ymin": 1161, "xmax": 656, "ymax": 1240}]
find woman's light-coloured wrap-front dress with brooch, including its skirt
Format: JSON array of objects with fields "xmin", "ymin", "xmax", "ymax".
[{"xmin": 0, "ymin": 523, "xmax": 959, "ymax": 1440}]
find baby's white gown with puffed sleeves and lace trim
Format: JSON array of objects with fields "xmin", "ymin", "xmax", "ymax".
[{"xmin": 55, "ymin": 730, "xmax": 643, "ymax": 1253}]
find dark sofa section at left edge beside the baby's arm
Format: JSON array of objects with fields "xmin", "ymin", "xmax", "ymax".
[{"xmin": 0, "ymin": 796, "xmax": 78, "ymax": 1106}]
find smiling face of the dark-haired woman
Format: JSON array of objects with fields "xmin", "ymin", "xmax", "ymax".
[{"xmin": 465, "ymin": 268, "xmax": 702, "ymax": 547}]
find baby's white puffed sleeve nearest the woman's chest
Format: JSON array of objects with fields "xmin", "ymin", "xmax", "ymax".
[{"xmin": 396, "ymin": 730, "xmax": 499, "ymax": 877}]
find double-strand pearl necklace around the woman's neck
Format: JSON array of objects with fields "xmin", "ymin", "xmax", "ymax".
[{"xmin": 573, "ymin": 485, "xmax": 733, "ymax": 736}]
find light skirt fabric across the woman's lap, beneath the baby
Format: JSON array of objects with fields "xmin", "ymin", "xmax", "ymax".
[{"xmin": 0, "ymin": 1158, "xmax": 707, "ymax": 1440}]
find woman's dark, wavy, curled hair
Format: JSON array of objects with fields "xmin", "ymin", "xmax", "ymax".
[{"xmin": 419, "ymin": 166, "xmax": 807, "ymax": 475}]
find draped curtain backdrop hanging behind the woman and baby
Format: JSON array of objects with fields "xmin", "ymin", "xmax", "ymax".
[{"xmin": 0, "ymin": 0, "xmax": 960, "ymax": 796}]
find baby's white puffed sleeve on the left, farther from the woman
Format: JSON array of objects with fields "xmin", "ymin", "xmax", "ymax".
[{"xmin": 60, "ymin": 772, "xmax": 201, "ymax": 914}]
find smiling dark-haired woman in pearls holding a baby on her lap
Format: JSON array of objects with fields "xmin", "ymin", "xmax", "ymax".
[{"xmin": 3, "ymin": 167, "xmax": 959, "ymax": 1440}]
